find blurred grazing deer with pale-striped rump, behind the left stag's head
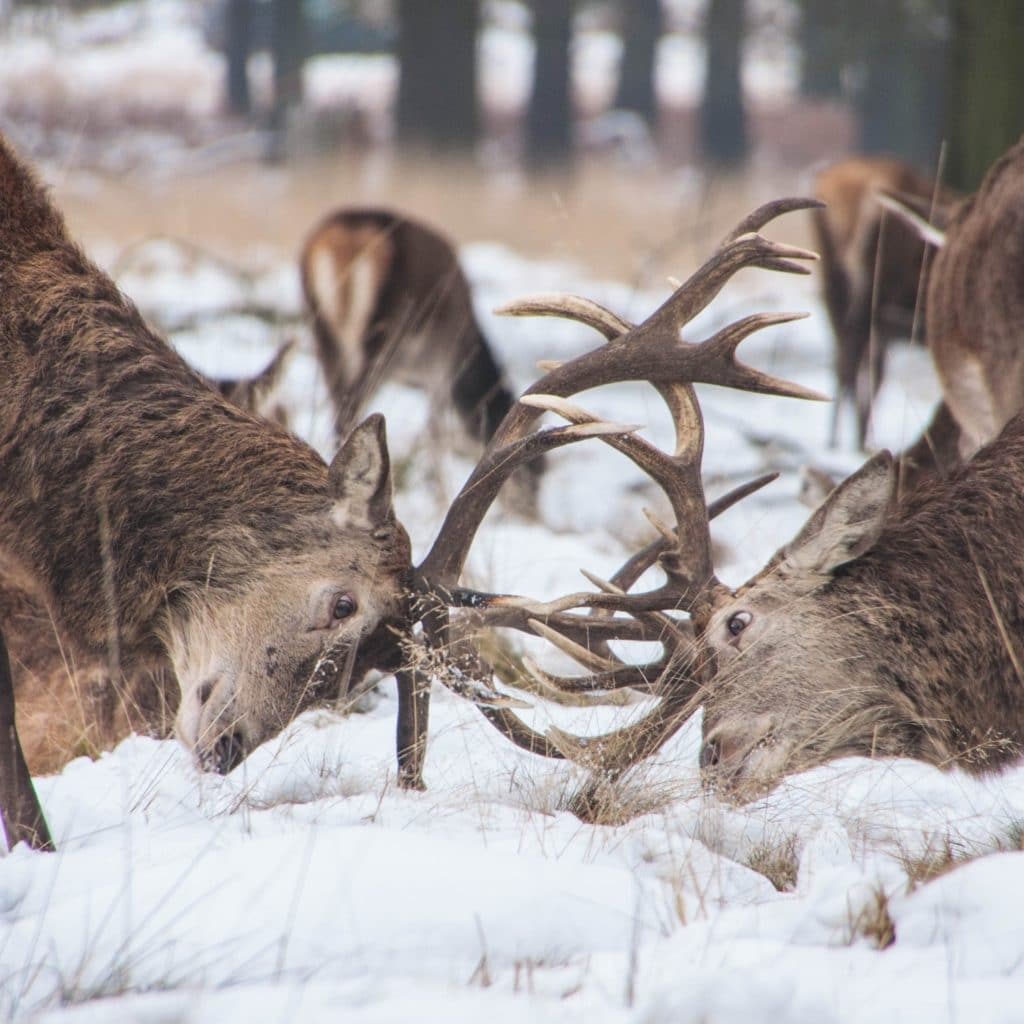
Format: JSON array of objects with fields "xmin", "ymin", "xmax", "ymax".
[{"xmin": 300, "ymin": 209, "xmax": 543, "ymax": 502}]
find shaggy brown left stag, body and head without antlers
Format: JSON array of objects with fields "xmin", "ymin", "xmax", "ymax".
[{"xmin": 0, "ymin": 141, "xmax": 410, "ymax": 847}]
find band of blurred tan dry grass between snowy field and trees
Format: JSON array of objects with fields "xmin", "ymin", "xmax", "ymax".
[{"xmin": 48, "ymin": 153, "xmax": 810, "ymax": 284}]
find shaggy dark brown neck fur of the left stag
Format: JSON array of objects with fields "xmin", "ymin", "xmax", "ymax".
[{"xmin": 0, "ymin": 139, "xmax": 329, "ymax": 659}]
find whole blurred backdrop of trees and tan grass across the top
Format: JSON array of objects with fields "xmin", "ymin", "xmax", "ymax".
[{"xmin": 0, "ymin": 0, "xmax": 1024, "ymax": 282}]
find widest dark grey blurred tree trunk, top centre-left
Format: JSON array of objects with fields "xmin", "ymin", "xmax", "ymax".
[{"xmin": 395, "ymin": 0, "xmax": 480, "ymax": 151}]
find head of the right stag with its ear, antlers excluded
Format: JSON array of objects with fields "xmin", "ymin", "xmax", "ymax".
[{"xmin": 694, "ymin": 452, "xmax": 920, "ymax": 795}]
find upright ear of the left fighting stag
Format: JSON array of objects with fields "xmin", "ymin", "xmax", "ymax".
[{"xmin": 328, "ymin": 413, "xmax": 394, "ymax": 528}]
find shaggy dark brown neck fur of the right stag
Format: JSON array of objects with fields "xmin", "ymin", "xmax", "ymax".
[{"xmin": 826, "ymin": 416, "xmax": 1024, "ymax": 770}]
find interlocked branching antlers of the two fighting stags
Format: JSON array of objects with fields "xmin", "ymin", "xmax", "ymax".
[{"xmin": 398, "ymin": 199, "xmax": 824, "ymax": 785}]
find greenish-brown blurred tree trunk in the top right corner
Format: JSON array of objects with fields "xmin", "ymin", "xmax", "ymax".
[{"xmin": 947, "ymin": 0, "xmax": 1024, "ymax": 190}]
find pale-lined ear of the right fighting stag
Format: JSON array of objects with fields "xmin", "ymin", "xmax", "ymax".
[{"xmin": 781, "ymin": 452, "xmax": 896, "ymax": 575}]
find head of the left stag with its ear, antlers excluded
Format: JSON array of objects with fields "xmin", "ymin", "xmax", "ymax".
[{"xmin": 167, "ymin": 415, "xmax": 410, "ymax": 772}]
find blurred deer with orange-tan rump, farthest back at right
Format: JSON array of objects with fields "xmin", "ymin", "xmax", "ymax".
[{"xmin": 813, "ymin": 157, "xmax": 950, "ymax": 447}]
